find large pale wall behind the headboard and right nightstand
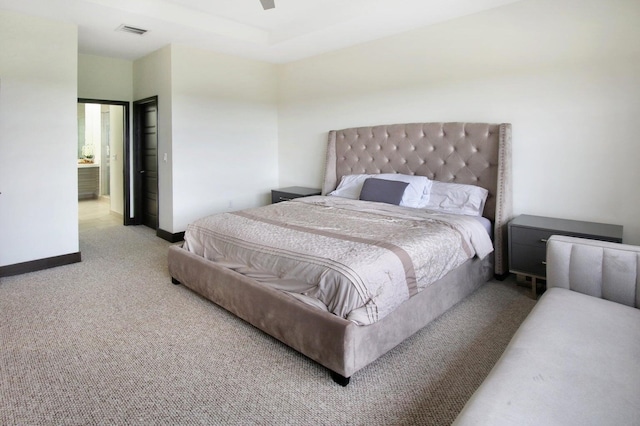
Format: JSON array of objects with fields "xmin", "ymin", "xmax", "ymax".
[{"xmin": 278, "ymin": 0, "xmax": 640, "ymax": 244}]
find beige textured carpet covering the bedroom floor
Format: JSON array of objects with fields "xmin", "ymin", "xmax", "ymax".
[{"xmin": 0, "ymin": 226, "xmax": 535, "ymax": 425}]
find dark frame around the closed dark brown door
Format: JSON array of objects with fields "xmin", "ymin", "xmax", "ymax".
[{"xmin": 130, "ymin": 96, "xmax": 160, "ymax": 228}]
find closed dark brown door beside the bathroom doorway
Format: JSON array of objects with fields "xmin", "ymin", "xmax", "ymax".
[{"xmin": 134, "ymin": 97, "xmax": 158, "ymax": 229}]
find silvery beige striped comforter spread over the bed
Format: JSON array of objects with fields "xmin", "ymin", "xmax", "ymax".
[{"xmin": 184, "ymin": 196, "xmax": 493, "ymax": 324}]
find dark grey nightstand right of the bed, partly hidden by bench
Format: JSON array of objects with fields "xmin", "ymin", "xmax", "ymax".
[{"xmin": 508, "ymin": 215, "xmax": 622, "ymax": 298}]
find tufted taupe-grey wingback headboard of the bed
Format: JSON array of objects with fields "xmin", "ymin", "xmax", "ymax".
[{"xmin": 322, "ymin": 123, "xmax": 512, "ymax": 275}]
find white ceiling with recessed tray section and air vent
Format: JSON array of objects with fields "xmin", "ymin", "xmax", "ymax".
[{"xmin": 0, "ymin": 0, "xmax": 518, "ymax": 63}]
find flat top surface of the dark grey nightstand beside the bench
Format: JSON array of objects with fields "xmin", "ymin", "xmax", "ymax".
[{"xmin": 509, "ymin": 214, "xmax": 622, "ymax": 241}]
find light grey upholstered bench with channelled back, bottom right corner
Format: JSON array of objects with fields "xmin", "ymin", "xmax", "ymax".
[{"xmin": 454, "ymin": 236, "xmax": 640, "ymax": 426}]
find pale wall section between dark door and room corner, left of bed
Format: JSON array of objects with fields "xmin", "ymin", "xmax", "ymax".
[{"xmin": 171, "ymin": 45, "xmax": 278, "ymax": 232}]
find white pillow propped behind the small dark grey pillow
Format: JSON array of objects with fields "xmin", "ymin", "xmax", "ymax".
[{"xmin": 329, "ymin": 173, "xmax": 432, "ymax": 208}]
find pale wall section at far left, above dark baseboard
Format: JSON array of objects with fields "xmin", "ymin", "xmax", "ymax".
[{"xmin": 0, "ymin": 10, "xmax": 79, "ymax": 266}]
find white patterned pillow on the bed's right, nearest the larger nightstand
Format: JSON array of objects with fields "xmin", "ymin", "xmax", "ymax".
[{"xmin": 424, "ymin": 180, "xmax": 489, "ymax": 216}]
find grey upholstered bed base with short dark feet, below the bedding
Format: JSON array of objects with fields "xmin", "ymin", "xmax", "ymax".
[{"xmin": 169, "ymin": 246, "xmax": 493, "ymax": 385}]
